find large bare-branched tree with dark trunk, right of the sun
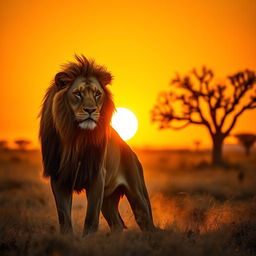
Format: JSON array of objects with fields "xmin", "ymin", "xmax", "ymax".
[{"xmin": 151, "ymin": 67, "xmax": 256, "ymax": 165}]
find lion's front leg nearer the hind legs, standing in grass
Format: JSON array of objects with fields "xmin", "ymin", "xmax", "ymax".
[{"xmin": 83, "ymin": 169, "xmax": 106, "ymax": 236}]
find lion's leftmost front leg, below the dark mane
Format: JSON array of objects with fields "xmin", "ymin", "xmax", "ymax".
[{"xmin": 51, "ymin": 179, "xmax": 73, "ymax": 234}]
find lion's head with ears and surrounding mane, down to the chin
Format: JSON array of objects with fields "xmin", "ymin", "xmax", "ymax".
[{"xmin": 44, "ymin": 56, "xmax": 114, "ymax": 143}]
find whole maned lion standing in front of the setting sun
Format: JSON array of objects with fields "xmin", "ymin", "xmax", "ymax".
[{"xmin": 39, "ymin": 55, "xmax": 155, "ymax": 236}]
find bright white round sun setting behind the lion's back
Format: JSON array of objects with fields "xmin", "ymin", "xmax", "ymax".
[{"xmin": 111, "ymin": 108, "xmax": 138, "ymax": 140}]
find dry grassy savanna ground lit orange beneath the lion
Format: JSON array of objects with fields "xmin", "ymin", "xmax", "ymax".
[{"xmin": 0, "ymin": 150, "xmax": 256, "ymax": 256}]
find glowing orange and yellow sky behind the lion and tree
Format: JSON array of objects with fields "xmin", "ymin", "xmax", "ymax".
[{"xmin": 0, "ymin": 0, "xmax": 256, "ymax": 147}]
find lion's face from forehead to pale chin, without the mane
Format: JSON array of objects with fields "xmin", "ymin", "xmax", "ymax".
[{"xmin": 67, "ymin": 76, "xmax": 105, "ymax": 130}]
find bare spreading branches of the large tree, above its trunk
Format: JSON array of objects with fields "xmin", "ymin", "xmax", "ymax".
[{"xmin": 151, "ymin": 67, "xmax": 256, "ymax": 141}]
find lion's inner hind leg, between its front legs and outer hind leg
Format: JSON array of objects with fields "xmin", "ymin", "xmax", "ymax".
[{"xmin": 101, "ymin": 187, "xmax": 126, "ymax": 232}]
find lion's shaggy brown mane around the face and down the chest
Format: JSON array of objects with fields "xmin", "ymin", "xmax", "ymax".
[{"xmin": 39, "ymin": 56, "xmax": 115, "ymax": 192}]
